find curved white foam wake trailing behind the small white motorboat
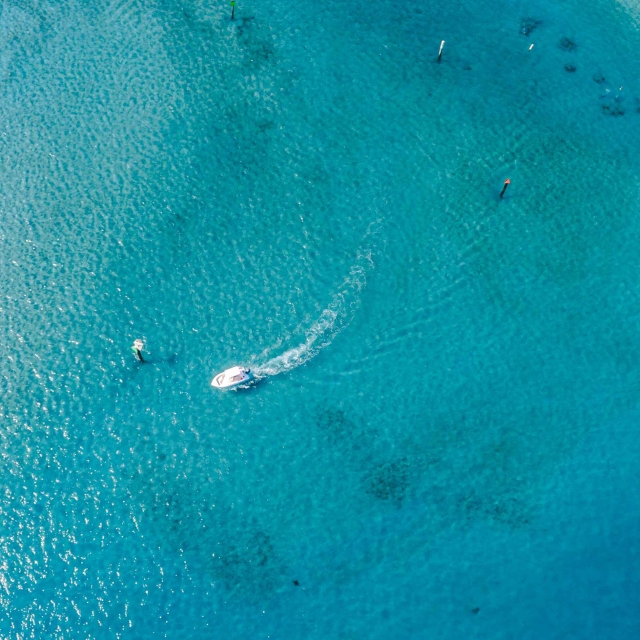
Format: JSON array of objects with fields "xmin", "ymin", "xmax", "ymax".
[{"xmin": 253, "ymin": 225, "xmax": 379, "ymax": 378}]
